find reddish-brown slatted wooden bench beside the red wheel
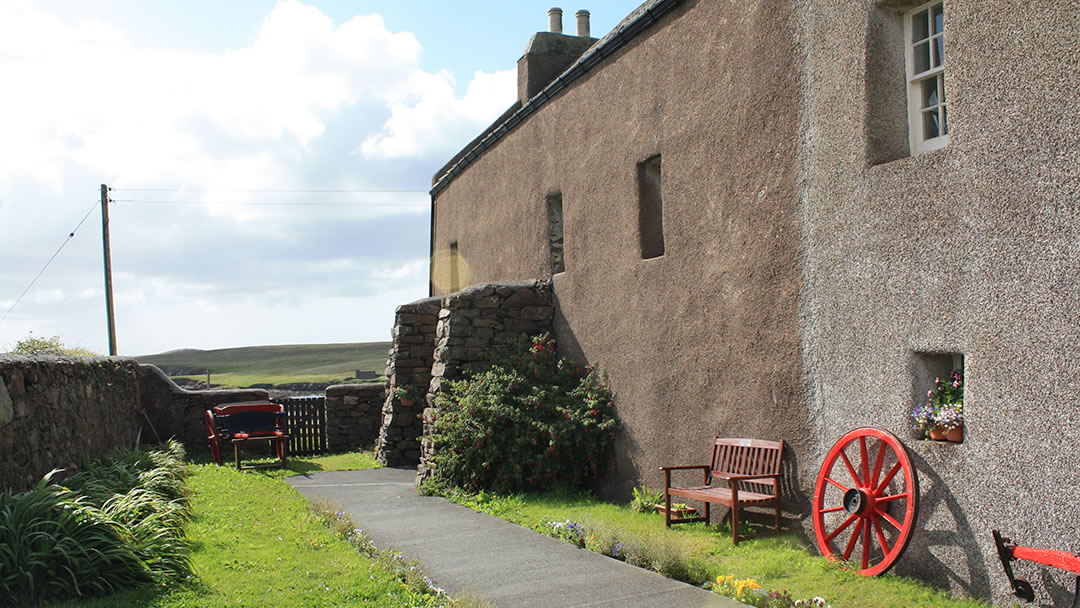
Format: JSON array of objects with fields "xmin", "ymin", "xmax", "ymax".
[{"xmin": 660, "ymin": 437, "xmax": 784, "ymax": 544}]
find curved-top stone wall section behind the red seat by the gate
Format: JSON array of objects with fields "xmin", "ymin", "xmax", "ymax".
[{"xmin": 138, "ymin": 364, "xmax": 269, "ymax": 452}]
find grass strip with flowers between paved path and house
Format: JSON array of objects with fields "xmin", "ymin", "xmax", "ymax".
[{"xmin": 455, "ymin": 494, "xmax": 988, "ymax": 608}]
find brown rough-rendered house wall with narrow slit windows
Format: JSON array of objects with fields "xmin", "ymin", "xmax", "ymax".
[{"xmin": 425, "ymin": 0, "xmax": 812, "ymax": 510}]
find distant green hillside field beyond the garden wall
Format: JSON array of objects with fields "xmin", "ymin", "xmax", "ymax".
[{"xmin": 135, "ymin": 342, "xmax": 390, "ymax": 387}]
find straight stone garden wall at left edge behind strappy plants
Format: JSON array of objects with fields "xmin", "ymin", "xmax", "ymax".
[{"xmin": 0, "ymin": 355, "xmax": 141, "ymax": 491}]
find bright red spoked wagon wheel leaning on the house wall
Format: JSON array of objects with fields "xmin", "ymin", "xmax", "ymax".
[{"xmin": 813, "ymin": 427, "xmax": 919, "ymax": 577}]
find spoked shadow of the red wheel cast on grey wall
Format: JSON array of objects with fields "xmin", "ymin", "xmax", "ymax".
[{"xmin": 896, "ymin": 450, "xmax": 989, "ymax": 597}]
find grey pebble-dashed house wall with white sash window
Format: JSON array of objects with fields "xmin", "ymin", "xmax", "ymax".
[{"xmin": 798, "ymin": 0, "xmax": 1080, "ymax": 606}]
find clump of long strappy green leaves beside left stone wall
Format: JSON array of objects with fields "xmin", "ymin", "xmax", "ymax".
[{"xmin": 0, "ymin": 443, "xmax": 191, "ymax": 608}]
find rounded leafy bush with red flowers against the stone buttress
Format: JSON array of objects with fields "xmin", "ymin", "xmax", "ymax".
[{"xmin": 432, "ymin": 334, "xmax": 618, "ymax": 494}]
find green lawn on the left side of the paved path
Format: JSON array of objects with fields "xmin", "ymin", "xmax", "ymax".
[{"xmin": 48, "ymin": 452, "xmax": 449, "ymax": 608}]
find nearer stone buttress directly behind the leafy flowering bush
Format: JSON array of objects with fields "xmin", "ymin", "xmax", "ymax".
[{"xmin": 417, "ymin": 281, "xmax": 555, "ymax": 484}]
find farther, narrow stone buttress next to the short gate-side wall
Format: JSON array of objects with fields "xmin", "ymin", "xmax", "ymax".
[{"xmin": 375, "ymin": 298, "xmax": 440, "ymax": 467}]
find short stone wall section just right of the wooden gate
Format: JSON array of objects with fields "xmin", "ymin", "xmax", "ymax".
[{"xmin": 326, "ymin": 382, "xmax": 387, "ymax": 451}]
